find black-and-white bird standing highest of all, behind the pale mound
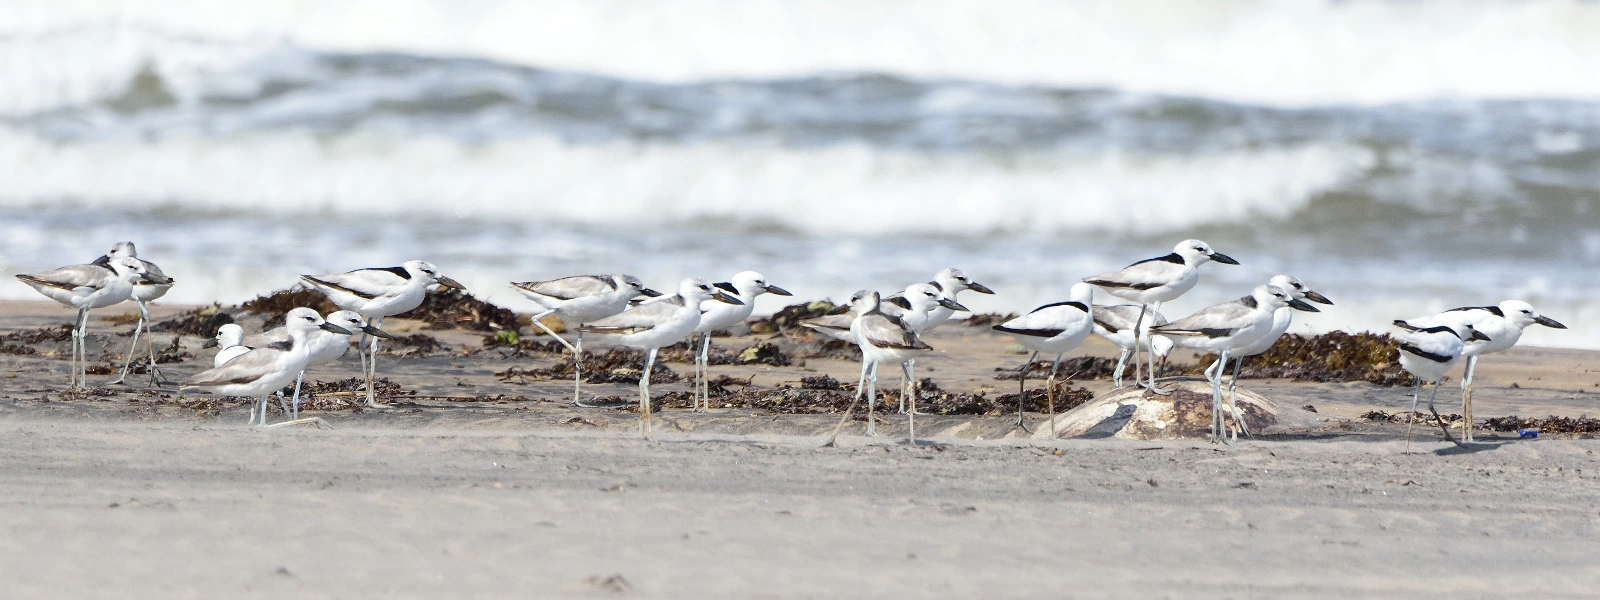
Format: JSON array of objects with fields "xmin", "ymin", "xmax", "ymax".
[{"xmin": 1083, "ymin": 240, "xmax": 1238, "ymax": 394}]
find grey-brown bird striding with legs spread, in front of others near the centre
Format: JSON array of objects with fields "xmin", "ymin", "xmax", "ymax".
[{"xmin": 824, "ymin": 290, "xmax": 933, "ymax": 446}]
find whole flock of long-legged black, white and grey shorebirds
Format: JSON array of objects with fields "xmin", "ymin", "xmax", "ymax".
[{"xmin": 16, "ymin": 240, "xmax": 1565, "ymax": 443}]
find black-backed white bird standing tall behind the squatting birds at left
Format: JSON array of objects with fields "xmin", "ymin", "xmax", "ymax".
[{"xmin": 301, "ymin": 261, "xmax": 467, "ymax": 408}]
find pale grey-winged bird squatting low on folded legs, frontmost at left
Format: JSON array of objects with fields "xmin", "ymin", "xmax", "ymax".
[{"xmin": 181, "ymin": 307, "xmax": 350, "ymax": 427}]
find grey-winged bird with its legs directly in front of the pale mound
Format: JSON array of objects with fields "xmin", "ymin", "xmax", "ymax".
[{"xmin": 1150, "ymin": 285, "xmax": 1317, "ymax": 443}]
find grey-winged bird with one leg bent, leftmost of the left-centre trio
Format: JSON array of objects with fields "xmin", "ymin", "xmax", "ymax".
[{"xmin": 510, "ymin": 275, "xmax": 661, "ymax": 403}]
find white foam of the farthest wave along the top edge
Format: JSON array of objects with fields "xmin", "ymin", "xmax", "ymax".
[{"xmin": 9, "ymin": 0, "xmax": 1600, "ymax": 107}]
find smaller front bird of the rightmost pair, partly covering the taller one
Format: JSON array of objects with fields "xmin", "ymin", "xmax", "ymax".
[{"xmin": 1394, "ymin": 316, "xmax": 1491, "ymax": 448}]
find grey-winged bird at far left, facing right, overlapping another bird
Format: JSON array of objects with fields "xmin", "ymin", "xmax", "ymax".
[{"xmin": 16, "ymin": 256, "xmax": 171, "ymax": 389}]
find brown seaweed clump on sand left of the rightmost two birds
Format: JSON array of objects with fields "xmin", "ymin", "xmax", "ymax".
[{"xmin": 1184, "ymin": 331, "xmax": 1416, "ymax": 386}]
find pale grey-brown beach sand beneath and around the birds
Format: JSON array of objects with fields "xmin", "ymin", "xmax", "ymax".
[{"xmin": 0, "ymin": 302, "xmax": 1600, "ymax": 598}]
